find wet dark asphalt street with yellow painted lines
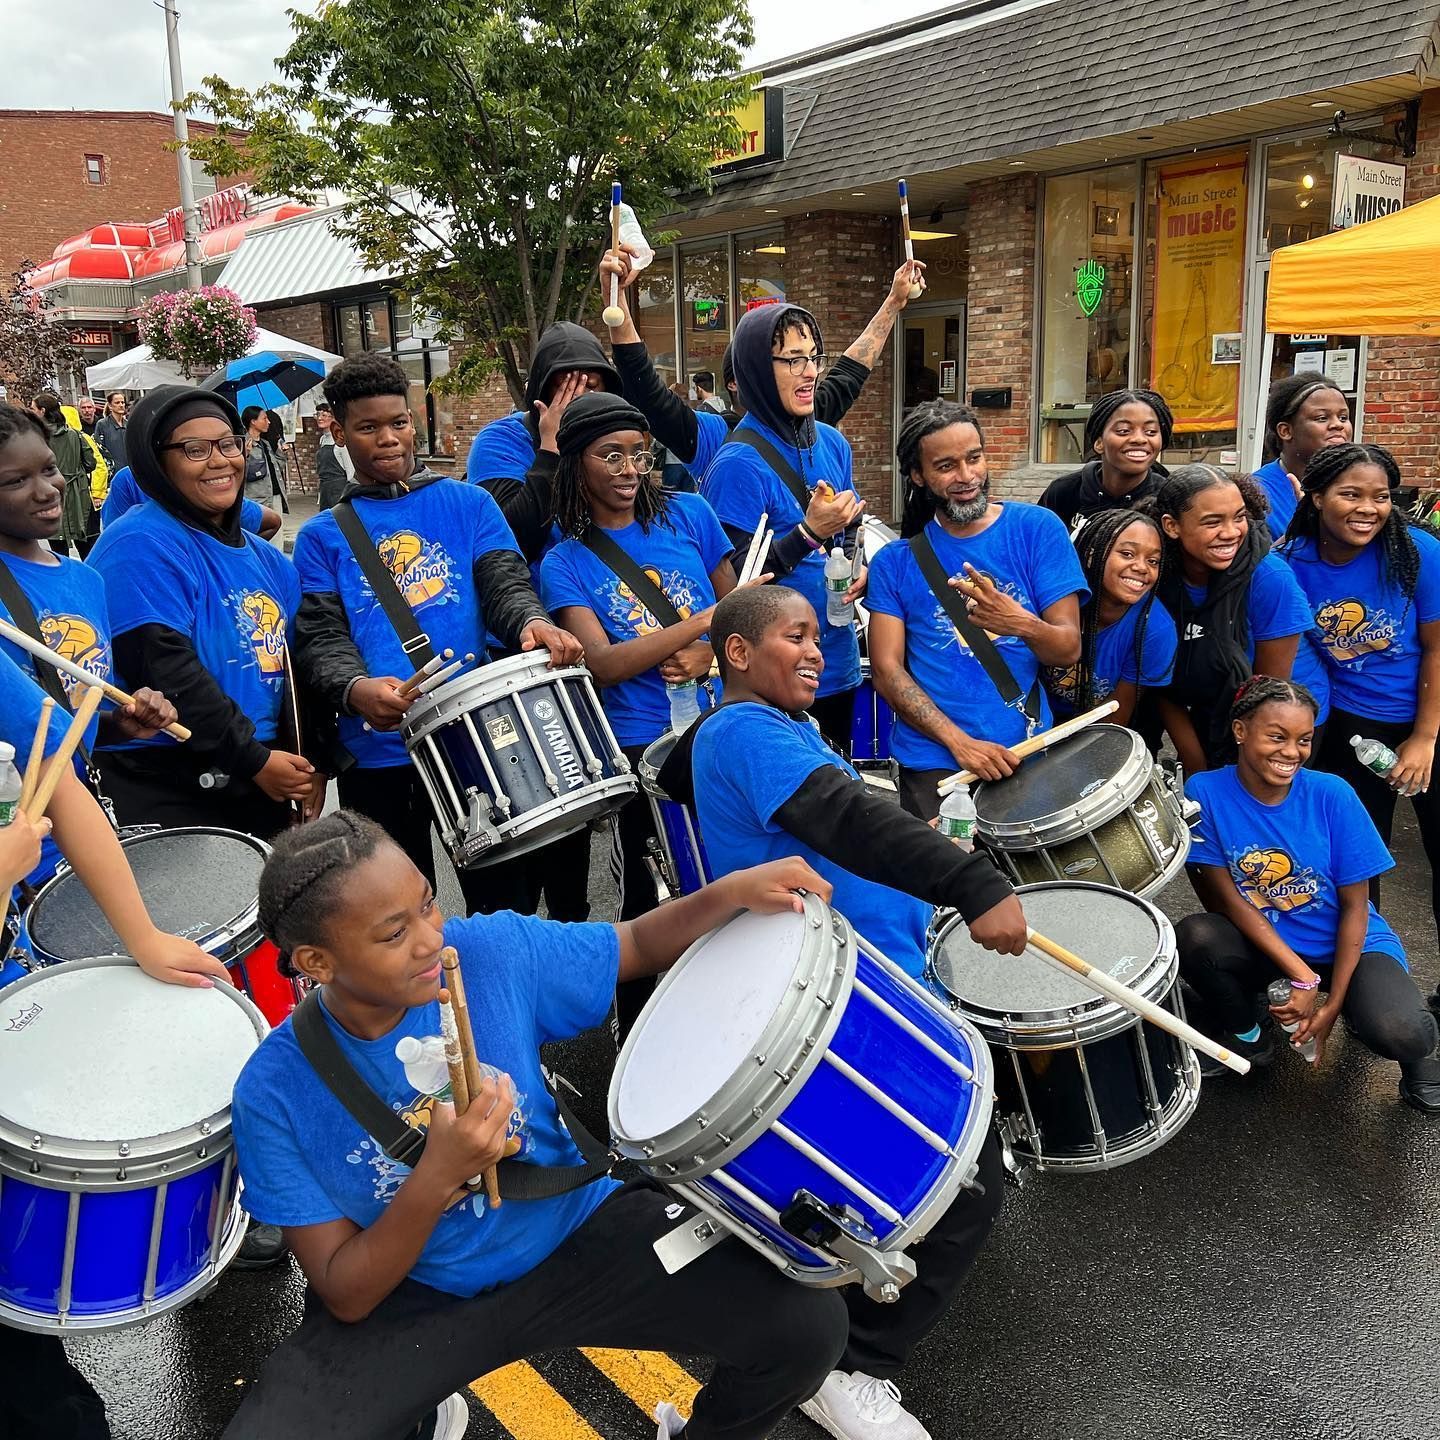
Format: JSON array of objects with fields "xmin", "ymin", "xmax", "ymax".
[{"xmin": 59, "ymin": 811, "xmax": 1440, "ymax": 1440}]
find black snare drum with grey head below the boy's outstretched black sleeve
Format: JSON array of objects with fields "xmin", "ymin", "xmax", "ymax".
[{"xmin": 930, "ymin": 884, "xmax": 1200, "ymax": 1171}]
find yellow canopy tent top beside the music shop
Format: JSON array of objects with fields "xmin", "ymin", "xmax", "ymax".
[{"xmin": 1264, "ymin": 196, "xmax": 1440, "ymax": 336}]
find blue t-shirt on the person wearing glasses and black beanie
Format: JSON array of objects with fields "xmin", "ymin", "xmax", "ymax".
[{"xmin": 540, "ymin": 494, "xmax": 732, "ymax": 744}]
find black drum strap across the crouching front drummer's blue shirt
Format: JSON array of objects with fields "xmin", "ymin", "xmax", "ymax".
[{"xmin": 289, "ymin": 991, "xmax": 616, "ymax": 1200}]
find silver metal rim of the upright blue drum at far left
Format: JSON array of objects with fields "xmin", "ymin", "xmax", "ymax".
[{"xmin": 0, "ymin": 955, "xmax": 269, "ymax": 1192}]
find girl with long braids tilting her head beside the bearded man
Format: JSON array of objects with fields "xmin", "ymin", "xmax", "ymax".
[{"xmin": 1041, "ymin": 510, "xmax": 1175, "ymax": 724}]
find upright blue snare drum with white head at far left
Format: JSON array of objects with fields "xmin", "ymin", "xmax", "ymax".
[{"xmin": 0, "ymin": 956, "xmax": 268, "ymax": 1324}]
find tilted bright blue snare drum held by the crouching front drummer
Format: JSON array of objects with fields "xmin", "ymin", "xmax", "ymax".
[{"xmin": 609, "ymin": 896, "xmax": 994, "ymax": 1300}]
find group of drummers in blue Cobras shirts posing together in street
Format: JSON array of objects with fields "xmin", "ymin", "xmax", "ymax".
[{"xmin": 0, "ymin": 241, "xmax": 1440, "ymax": 1440}]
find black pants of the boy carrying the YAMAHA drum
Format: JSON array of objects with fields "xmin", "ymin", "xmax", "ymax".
[{"xmin": 338, "ymin": 765, "xmax": 590, "ymax": 920}]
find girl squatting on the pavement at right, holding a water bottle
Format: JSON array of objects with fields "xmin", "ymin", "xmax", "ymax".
[{"xmin": 1175, "ymin": 675, "xmax": 1440, "ymax": 1115}]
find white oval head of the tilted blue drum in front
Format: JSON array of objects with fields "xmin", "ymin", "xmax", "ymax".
[{"xmin": 612, "ymin": 912, "xmax": 806, "ymax": 1139}]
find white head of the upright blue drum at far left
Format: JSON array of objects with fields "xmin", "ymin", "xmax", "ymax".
[{"xmin": 0, "ymin": 960, "xmax": 265, "ymax": 1142}]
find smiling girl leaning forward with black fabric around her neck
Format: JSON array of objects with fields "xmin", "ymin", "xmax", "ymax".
[{"xmin": 1146, "ymin": 465, "xmax": 1323, "ymax": 775}]
